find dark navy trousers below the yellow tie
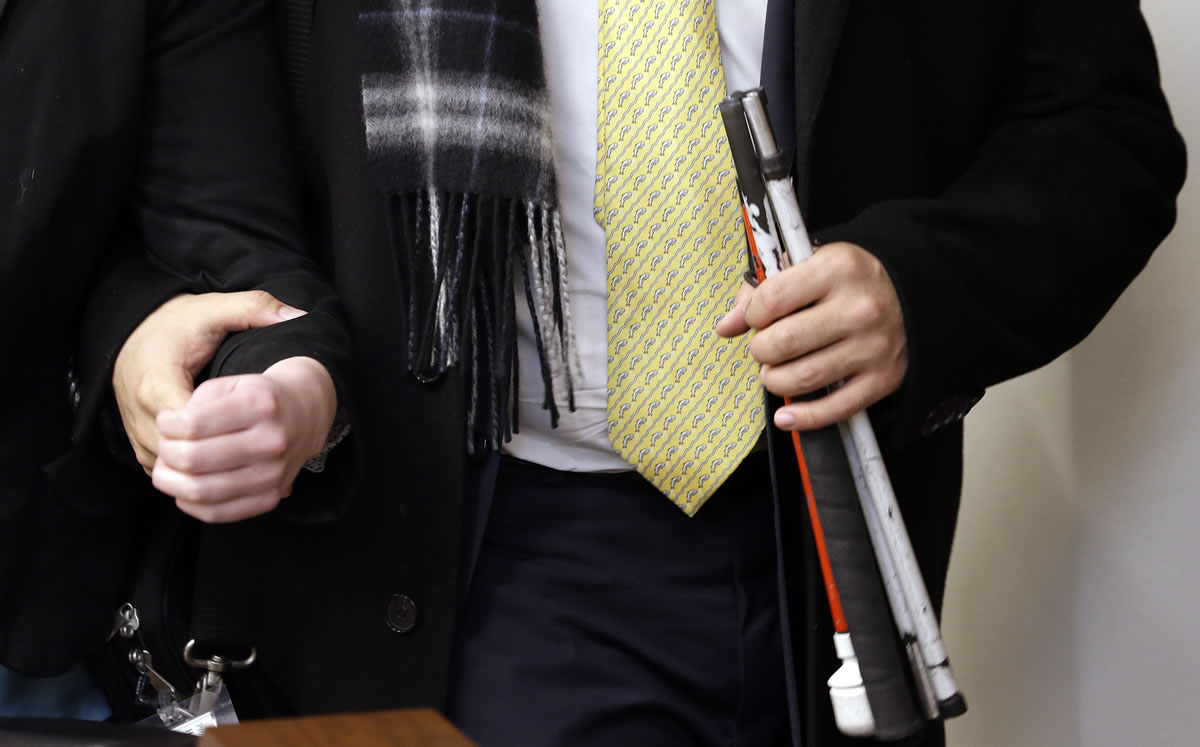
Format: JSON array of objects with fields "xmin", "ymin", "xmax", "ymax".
[{"xmin": 450, "ymin": 454, "xmax": 790, "ymax": 747}]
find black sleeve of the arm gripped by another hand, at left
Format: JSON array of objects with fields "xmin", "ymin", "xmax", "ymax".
[{"xmin": 76, "ymin": 0, "xmax": 356, "ymax": 520}]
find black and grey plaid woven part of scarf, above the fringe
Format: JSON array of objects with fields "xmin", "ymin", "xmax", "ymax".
[{"xmin": 360, "ymin": 0, "xmax": 556, "ymax": 205}]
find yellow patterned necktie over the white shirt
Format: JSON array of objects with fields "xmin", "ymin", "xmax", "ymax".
[{"xmin": 595, "ymin": 0, "xmax": 764, "ymax": 515}]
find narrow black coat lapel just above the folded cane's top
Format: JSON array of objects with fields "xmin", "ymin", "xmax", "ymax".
[{"xmin": 793, "ymin": 0, "xmax": 852, "ymax": 208}]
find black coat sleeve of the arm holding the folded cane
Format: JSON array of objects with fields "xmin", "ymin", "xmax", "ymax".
[{"xmin": 817, "ymin": 0, "xmax": 1184, "ymax": 441}]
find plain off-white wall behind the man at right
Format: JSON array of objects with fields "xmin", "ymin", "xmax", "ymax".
[{"xmin": 944, "ymin": 0, "xmax": 1200, "ymax": 747}]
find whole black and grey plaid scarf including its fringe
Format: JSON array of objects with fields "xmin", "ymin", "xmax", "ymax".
[{"xmin": 359, "ymin": 0, "xmax": 578, "ymax": 453}]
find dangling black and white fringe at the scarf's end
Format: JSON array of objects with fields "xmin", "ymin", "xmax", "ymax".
[{"xmin": 390, "ymin": 189, "xmax": 582, "ymax": 454}]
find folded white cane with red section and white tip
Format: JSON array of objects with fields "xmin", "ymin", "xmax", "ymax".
[{"xmin": 721, "ymin": 90, "xmax": 966, "ymax": 739}]
